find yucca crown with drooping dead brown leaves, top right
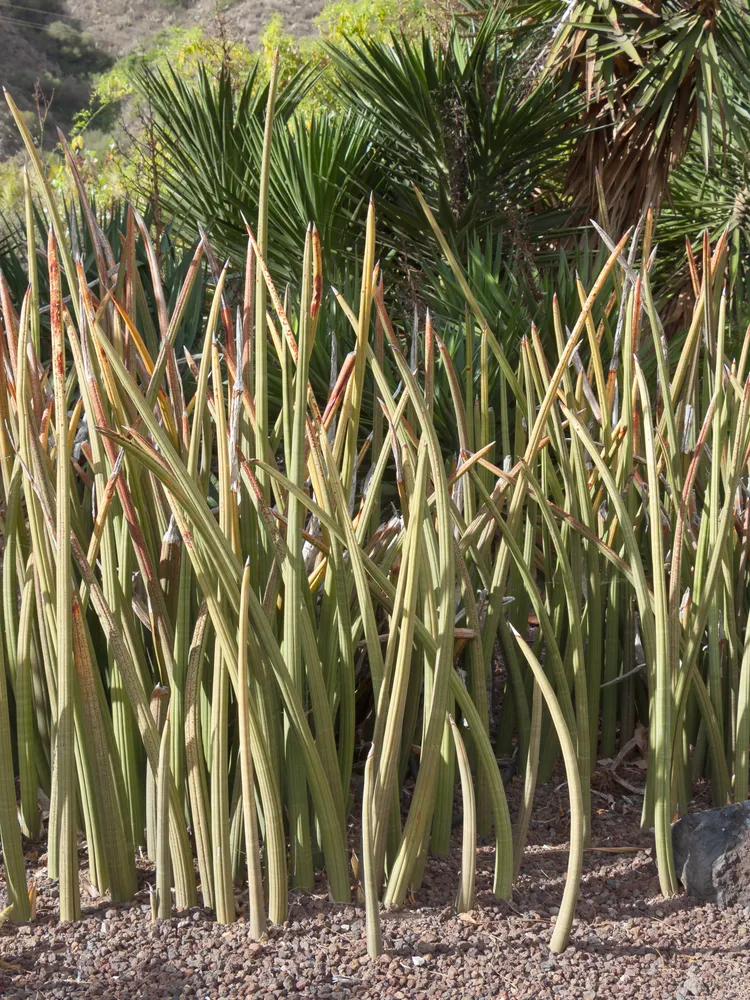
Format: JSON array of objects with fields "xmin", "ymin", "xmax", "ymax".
[{"xmin": 542, "ymin": 0, "xmax": 750, "ymax": 232}]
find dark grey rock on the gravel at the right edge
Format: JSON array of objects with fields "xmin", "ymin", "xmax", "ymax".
[{"xmin": 672, "ymin": 800, "xmax": 750, "ymax": 908}]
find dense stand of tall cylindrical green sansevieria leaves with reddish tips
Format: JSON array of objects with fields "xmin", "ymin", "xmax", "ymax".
[{"xmin": 0, "ymin": 72, "xmax": 750, "ymax": 955}]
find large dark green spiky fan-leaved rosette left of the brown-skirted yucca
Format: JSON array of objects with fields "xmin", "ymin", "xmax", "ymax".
[{"xmin": 329, "ymin": 9, "xmax": 579, "ymax": 257}]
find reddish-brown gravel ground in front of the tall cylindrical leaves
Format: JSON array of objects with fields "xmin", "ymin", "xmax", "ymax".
[{"xmin": 0, "ymin": 777, "xmax": 750, "ymax": 1000}]
